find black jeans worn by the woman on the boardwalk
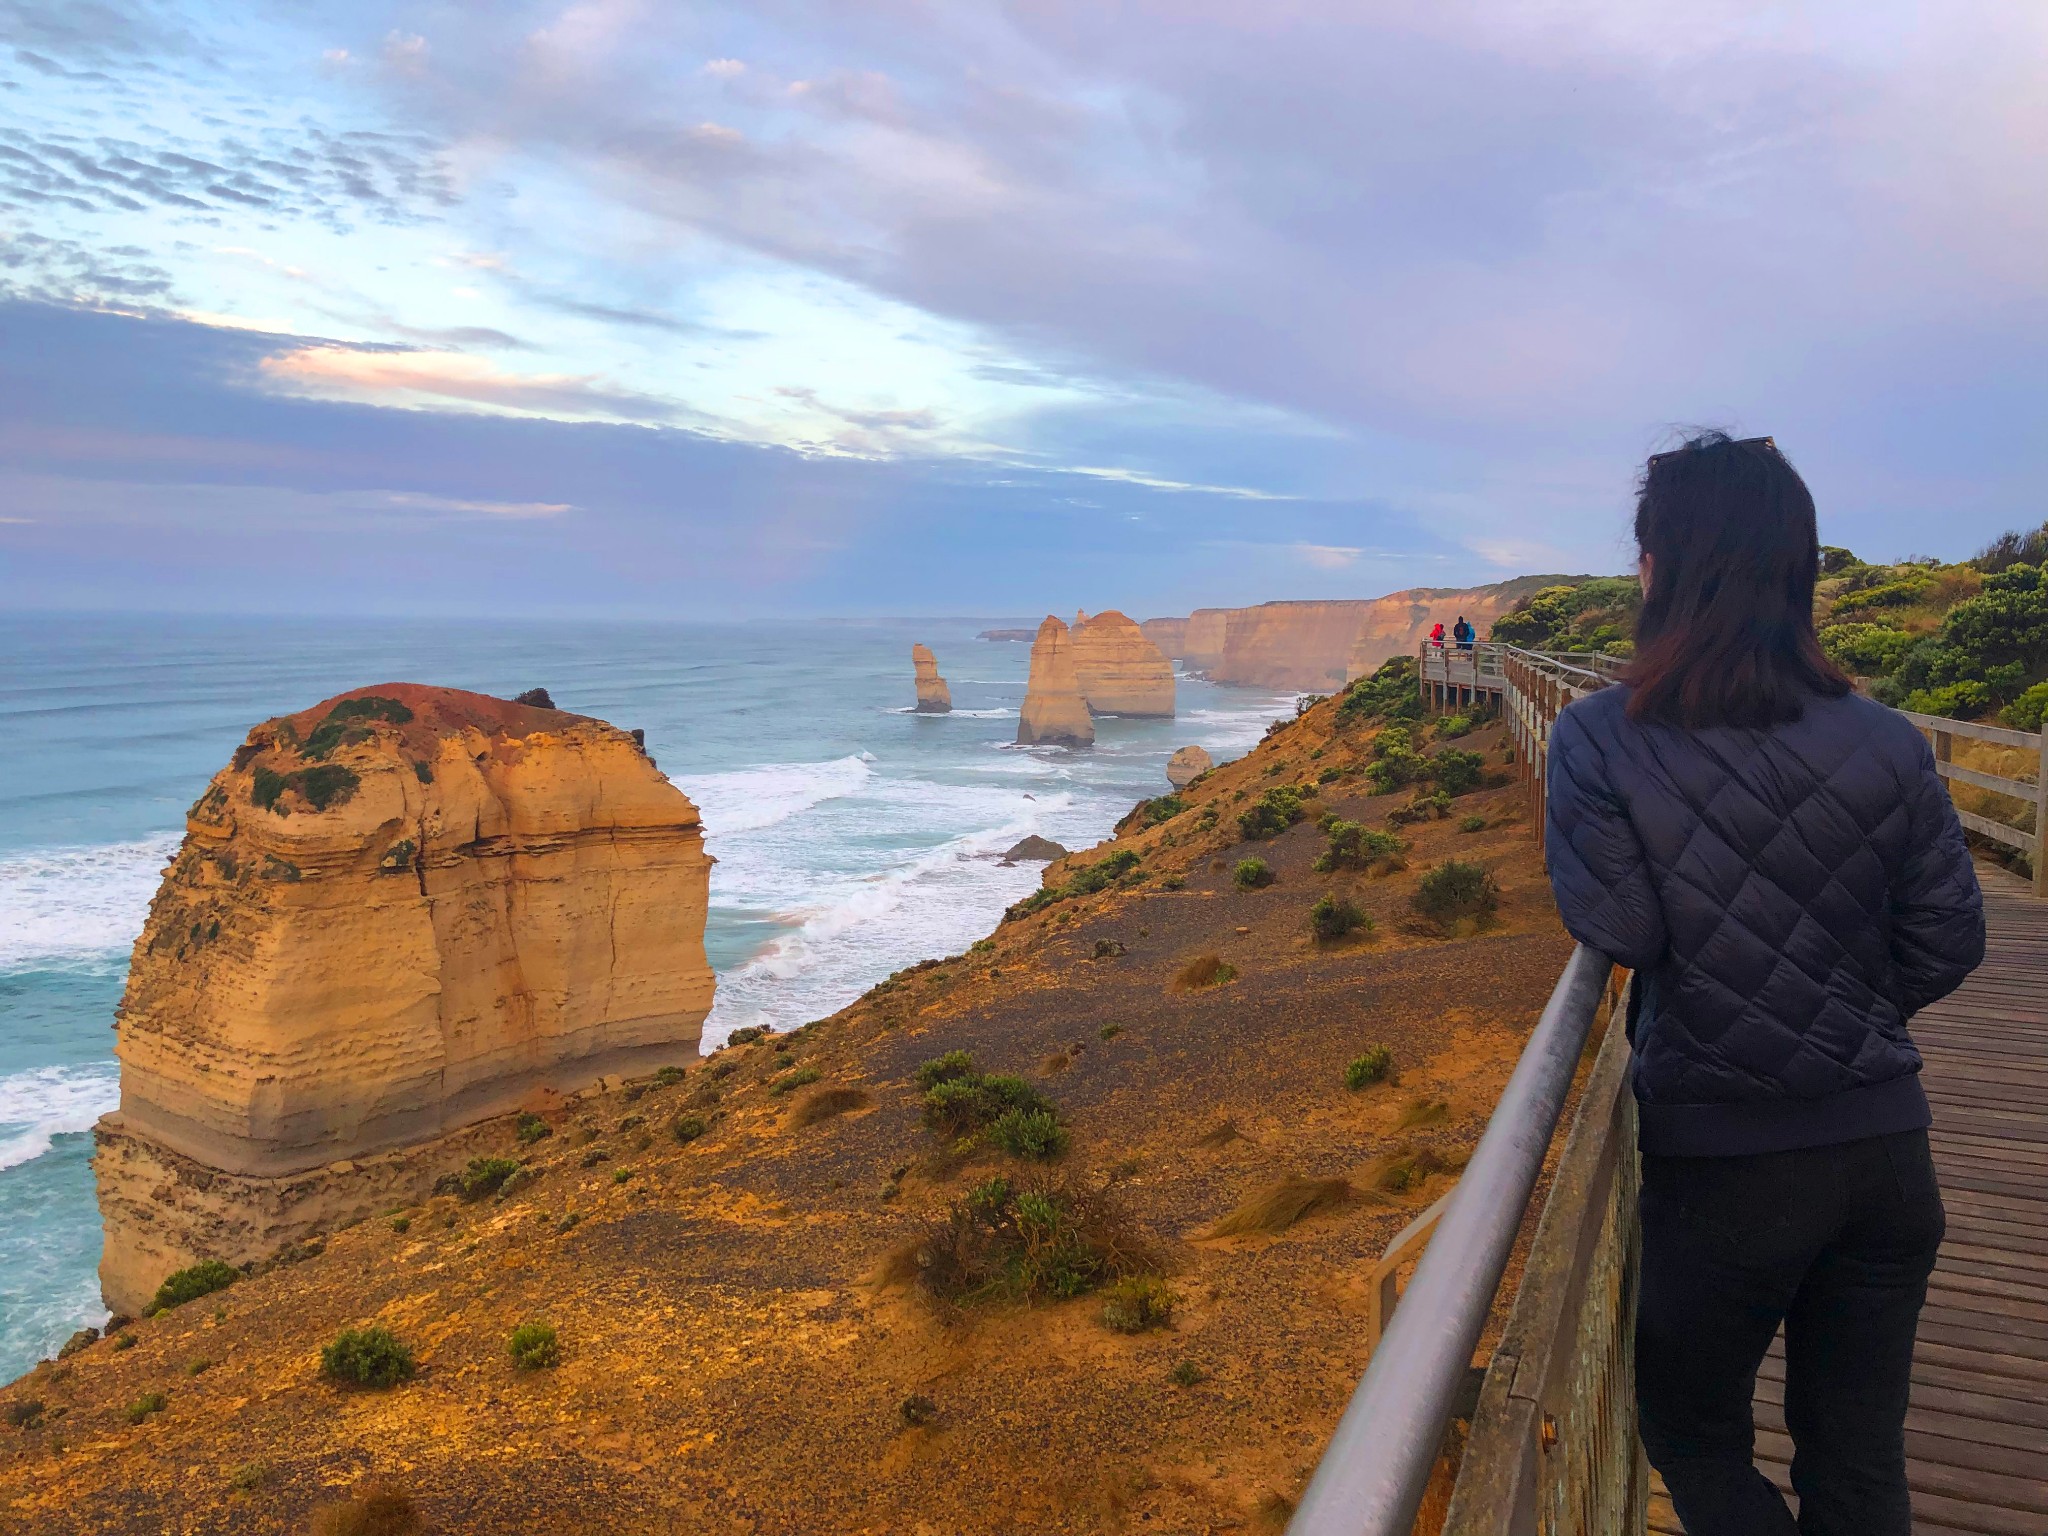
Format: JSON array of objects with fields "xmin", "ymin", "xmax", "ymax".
[{"xmin": 1636, "ymin": 1130, "xmax": 1944, "ymax": 1536}]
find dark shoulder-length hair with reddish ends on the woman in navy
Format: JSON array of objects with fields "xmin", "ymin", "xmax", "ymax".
[{"xmin": 1626, "ymin": 432, "xmax": 1849, "ymax": 729}]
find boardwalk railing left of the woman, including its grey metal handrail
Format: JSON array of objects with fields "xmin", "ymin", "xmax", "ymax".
[{"xmin": 1288, "ymin": 643, "xmax": 1647, "ymax": 1536}]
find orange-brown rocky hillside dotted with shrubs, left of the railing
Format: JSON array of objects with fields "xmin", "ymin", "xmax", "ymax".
[{"xmin": 0, "ymin": 684, "xmax": 1569, "ymax": 1536}]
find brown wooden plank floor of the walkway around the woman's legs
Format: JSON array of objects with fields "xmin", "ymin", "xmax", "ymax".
[{"xmin": 1651, "ymin": 864, "xmax": 2048, "ymax": 1536}]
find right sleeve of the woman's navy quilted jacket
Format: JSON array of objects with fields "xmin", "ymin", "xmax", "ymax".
[{"xmin": 1890, "ymin": 731, "xmax": 1985, "ymax": 1018}]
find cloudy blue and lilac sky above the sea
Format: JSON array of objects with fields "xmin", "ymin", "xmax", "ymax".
[{"xmin": 0, "ymin": 0, "xmax": 2048, "ymax": 618}]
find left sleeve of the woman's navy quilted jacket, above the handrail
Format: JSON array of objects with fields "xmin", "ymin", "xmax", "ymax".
[{"xmin": 1544, "ymin": 709, "xmax": 1665, "ymax": 971}]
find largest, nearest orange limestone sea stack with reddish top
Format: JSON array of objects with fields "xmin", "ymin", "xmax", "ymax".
[{"xmin": 94, "ymin": 684, "xmax": 713, "ymax": 1313}]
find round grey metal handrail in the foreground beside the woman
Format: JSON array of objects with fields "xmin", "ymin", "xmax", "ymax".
[{"xmin": 1288, "ymin": 944, "xmax": 1614, "ymax": 1536}]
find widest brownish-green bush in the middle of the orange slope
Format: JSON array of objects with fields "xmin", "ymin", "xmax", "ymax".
[{"xmin": 911, "ymin": 1178, "xmax": 1153, "ymax": 1305}]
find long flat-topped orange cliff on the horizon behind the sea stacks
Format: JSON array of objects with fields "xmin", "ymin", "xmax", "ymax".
[{"xmin": 1143, "ymin": 575, "xmax": 1581, "ymax": 692}]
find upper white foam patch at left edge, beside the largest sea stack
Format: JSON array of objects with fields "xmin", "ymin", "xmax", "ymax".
[{"xmin": 0, "ymin": 831, "xmax": 178, "ymax": 971}]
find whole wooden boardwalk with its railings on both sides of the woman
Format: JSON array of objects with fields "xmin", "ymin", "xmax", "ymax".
[{"xmin": 1288, "ymin": 643, "xmax": 2048, "ymax": 1536}]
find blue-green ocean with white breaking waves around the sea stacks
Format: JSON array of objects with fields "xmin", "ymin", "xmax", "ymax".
[{"xmin": 0, "ymin": 614, "xmax": 1294, "ymax": 1380}]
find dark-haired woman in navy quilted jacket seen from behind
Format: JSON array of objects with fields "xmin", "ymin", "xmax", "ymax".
[{"xmin": 1548, "ymin": 432, "xmax": 1985, "ymax": 1536}]
